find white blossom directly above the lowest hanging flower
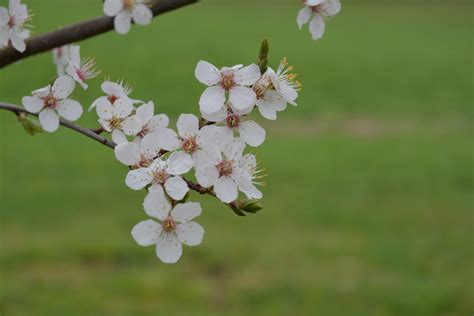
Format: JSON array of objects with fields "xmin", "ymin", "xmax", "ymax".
[{"xmin": 125, "ymin": 152, "xmax": 194, "ymax": 201}]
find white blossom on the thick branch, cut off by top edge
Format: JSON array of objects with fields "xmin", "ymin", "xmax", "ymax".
[{"xmin": 104, "ymin": 0, "xmax": 153, "ymax": 34}]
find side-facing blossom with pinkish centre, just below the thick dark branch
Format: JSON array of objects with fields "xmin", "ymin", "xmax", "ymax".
[{"xmin": 66, "ymin": 45, "xmax": 100, "ymax": 90}]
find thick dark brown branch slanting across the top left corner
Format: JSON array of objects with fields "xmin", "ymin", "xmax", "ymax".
[{"xmin": 0, "ymin": 0, "xmax": 199, "ymax": 68}]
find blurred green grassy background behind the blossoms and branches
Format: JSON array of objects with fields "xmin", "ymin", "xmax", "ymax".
[{"xmin": 0, "ymin": 0, "xmax": 474, "ymax": 316}]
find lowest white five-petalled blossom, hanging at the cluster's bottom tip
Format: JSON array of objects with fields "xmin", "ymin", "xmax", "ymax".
[{"xmin": 132, "ymin": 190, "xmax": 204, "ymax": 263}]
